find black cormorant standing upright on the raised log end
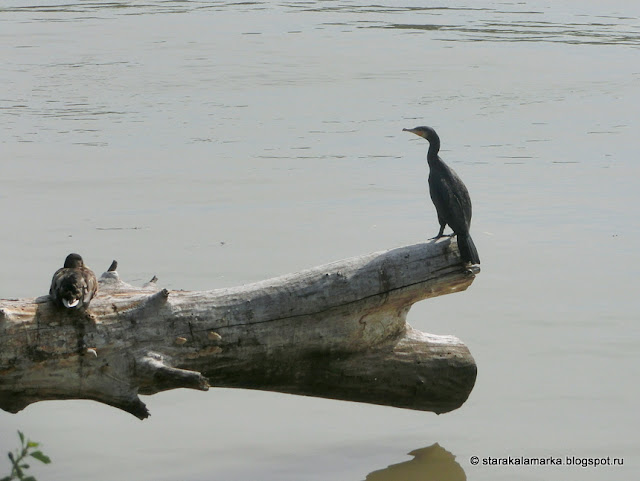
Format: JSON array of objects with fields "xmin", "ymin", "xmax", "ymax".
[{"xmin": 403, "ymin": 127, "xmax": 480, "ymax": 264}]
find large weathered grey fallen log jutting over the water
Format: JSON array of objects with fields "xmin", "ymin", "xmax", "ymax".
[{"xmin": 0, "ymin": 238, "xmax": 479, "ymax": 419}]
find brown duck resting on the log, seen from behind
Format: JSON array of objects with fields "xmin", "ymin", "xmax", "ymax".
[{"xmin": 49, "ymin": 254, "xmax": 98, "ymax": 309}]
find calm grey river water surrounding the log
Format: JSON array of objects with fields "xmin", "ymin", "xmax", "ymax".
[{"xmin": 0, "ymin": 0, "xmax": 640, "ymax": 481}]
